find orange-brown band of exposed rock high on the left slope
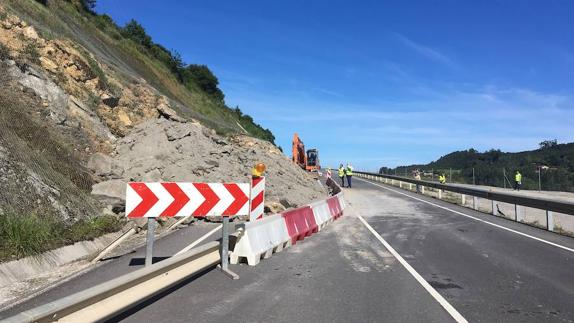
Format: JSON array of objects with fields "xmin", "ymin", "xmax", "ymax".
[{"xmin": 0, "ymin": 15, "xmax": 185, "ymax": 140}]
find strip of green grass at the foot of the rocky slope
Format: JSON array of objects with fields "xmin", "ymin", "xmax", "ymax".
[{"xmin": 0, "ymin": 211, "xmax": 122, "ymax": 261}]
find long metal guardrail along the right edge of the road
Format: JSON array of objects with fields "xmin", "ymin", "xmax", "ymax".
[{"xmin": 354, "ymin": 171, "xmax": 574, "ymax": 215}]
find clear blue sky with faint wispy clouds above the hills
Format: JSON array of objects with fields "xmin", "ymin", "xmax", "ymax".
[{"xmin": 97, "ymin": 0, "xmax": 574, "ymax": 170}]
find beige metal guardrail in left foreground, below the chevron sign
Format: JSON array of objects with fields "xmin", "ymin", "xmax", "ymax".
[{"xmin": 2, "ymin": 241, "xmax": 221, "ymax": 323}]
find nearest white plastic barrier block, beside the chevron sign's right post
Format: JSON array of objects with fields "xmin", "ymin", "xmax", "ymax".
[{"xmin": 230, "ymin": 214, "xmax": 291, "ymax": 266}]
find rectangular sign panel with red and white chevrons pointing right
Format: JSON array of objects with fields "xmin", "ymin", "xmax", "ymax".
[{"xmin": 126, "ymin": 182, "xmax": 249, "ymax": 218}]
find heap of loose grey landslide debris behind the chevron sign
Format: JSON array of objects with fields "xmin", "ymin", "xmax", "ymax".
[{"xmin": 88, "ymin": 118, "xmax": 327, "ymax": 219}]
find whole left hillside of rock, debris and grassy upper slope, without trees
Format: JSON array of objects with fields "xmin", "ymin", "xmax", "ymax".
[{"xmin": 0, "ymin": 0, "xmax": 326, "ymax": 256}]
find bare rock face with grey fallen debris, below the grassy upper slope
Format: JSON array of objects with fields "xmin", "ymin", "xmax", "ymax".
[{"xmin": 0, "ymin": 8, "xmax": 326, "ymax": 225}]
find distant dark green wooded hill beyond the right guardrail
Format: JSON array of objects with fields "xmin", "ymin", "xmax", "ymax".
[{"xmin": 380, "ymin": 140, "xmax": 574, "ymax": 192}]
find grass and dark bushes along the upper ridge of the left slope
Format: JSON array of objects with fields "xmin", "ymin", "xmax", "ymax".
[{"xmin": 19, "ymin": 0, "xmax": 275, "ymax": 143}]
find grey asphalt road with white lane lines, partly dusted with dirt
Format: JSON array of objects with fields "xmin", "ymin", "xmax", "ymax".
[{"xmin": 0, "ymin": 179, "xmax": 574, "ymax": 322}]
